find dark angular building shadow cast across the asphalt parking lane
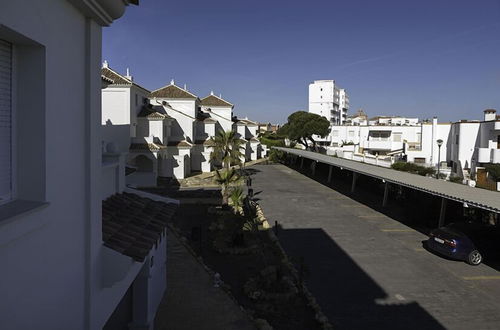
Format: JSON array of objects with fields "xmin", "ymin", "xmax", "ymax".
[{"xmin": 278, "ymin": 228, "xmax": 445, "ymax": 329}]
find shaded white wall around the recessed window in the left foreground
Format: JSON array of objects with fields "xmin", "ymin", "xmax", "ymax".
[{"xmin": 0, "ymin": 0, "xmax": 94, "ymax": 329}]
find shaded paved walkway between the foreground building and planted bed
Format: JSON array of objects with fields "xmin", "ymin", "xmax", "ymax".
[{"xmin": 155, "ymin": 231, "xmax": 255, "ymax": 330}]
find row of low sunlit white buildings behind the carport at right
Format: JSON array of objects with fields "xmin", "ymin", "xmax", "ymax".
[{"xmin": 328, "ymin": 109, "xmax": 500, "ymax": 183}]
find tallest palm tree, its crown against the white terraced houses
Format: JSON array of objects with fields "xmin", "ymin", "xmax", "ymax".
[{"xmin": 210, "ymin": 130, "xmax": 244, "ymax": 169}]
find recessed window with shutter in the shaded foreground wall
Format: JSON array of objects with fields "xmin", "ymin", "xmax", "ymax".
[{"xmin": 0, "ymin": 24, "xmax": 48, "ymax": 222}]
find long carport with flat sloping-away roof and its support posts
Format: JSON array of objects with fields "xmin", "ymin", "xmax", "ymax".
[{"xmin": 273, "ymin": 147, "xmax": 500, "ymax": 226}]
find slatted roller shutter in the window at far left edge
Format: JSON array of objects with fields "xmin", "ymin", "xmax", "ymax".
[{"xmin": 0, "ymin": 39, "xmax": 12, "ymax": 204}]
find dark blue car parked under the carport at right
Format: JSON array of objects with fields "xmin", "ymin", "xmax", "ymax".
[{"xmin": 426, "ymin": 222, "xmax": 500, "ymax": 266}]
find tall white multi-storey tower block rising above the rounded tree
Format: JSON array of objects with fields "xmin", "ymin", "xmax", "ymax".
[{"xmin": 309, "ymin": 80, "xmax": 349, "ymax": 125}]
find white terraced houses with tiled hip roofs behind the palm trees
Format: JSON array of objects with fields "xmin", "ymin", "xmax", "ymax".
[{"xmin": 101, "ymin": 66, "xmax": 266, "ymax": 186}]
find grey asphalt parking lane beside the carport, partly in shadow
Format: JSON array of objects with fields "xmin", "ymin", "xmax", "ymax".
[{"xmin": 253, "ymin": 165, "xmax": 500, "ymax": 330}]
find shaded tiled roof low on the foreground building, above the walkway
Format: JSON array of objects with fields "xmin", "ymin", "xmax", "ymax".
[{"xmin": 102, "ymin": 193, "xmax": 177, "ymax": 262}]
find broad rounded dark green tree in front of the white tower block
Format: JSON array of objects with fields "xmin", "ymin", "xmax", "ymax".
[{"xmin": 278, "ymin": 111, "xmax": 330, "ymax": 149}]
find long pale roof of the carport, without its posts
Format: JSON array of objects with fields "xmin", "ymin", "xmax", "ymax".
[{"xmin": 273, "ymin": 147, "xmax": 500, "ymax": 213}]
